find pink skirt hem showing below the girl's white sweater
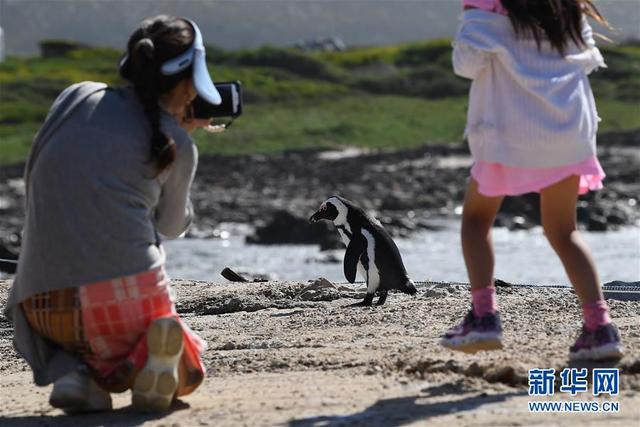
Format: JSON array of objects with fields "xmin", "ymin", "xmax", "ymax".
[{"xmin": 471, "ymin": 156, "xmax": 605, "ymax": 197}]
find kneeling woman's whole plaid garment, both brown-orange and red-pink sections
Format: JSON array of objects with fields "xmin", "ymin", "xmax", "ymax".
[{"xmin": 22, "ymin": 268, "xmax": 206, "ymax": 395}]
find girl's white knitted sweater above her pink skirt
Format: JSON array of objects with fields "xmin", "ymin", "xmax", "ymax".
[{"xmin": 453, "ymin": 9, "xmax": 606, "ymax": 168}]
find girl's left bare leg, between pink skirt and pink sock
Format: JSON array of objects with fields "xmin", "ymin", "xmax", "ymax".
[{"xmin": 461, "ymin": 178, "xmax": 503, "ymax": 289}]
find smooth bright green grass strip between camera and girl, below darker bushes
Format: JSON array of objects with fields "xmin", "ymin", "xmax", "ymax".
[{"xmin": 195, "ymin": 95, "xmax": 465, "ymax": 154}]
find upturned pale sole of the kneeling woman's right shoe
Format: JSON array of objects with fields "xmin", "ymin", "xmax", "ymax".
[{"xmin": 132, "ymin": 317, "xmax": 183, "ymax": 412}]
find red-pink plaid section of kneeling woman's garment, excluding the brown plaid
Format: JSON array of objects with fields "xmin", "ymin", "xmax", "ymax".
[{"xmin": 78, "ymin": 267, "xmax": 206, "ymax": 396}]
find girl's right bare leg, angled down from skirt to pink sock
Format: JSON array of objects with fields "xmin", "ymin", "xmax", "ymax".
[{"xmin": 540, "ymin": 175, "xmax": 603, "ymax": 305}]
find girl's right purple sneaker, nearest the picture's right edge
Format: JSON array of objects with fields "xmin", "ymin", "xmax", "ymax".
[{"xmin": 569, "ymin": 324, "xmax": 624, "ymax": 360}]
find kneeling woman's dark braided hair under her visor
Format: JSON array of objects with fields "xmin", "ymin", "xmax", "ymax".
[{"xmin": 120, "ymin": 15, "xmax": 194, "ymax": 173}]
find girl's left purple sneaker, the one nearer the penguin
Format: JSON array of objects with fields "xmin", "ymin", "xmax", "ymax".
[{"xmin": 440, "ymin": 310, "xmax": 502, "ymax": 353}]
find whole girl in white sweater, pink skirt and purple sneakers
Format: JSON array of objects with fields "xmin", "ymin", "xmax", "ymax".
[{"xmin": 441, "ymin": 0, "xmax": 623, "ymax": 360}]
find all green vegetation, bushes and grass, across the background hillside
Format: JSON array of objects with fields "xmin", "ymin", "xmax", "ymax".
[{"xmin": 0, "ymin": 40, "xmax": 640, "ymax": 164}]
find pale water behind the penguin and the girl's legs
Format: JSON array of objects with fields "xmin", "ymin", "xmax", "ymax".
[{"xmin": 165, "ymin": 222, "xmax": 640, "ymax": 285}]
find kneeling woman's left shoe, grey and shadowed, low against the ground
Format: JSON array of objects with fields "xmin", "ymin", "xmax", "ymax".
[{"xmin": 49, "ymin": 370, "xmax": 113, "ymax": 413}]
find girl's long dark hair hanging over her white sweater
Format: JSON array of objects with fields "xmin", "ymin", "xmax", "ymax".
[{"xmin": 501, "ymin": 0, "xmax": 609, "ymax": 54}]
